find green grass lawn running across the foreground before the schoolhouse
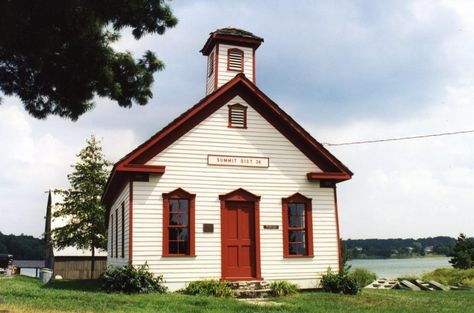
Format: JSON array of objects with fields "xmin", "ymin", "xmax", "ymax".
[{"xmin": 0, "ymin": 277, "xmax": 474, "ymax": 313}]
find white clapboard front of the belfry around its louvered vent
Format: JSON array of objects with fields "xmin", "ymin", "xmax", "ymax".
[{"xmin": 217, "ymin": 44, "xmax": 254, "ymax": 88}]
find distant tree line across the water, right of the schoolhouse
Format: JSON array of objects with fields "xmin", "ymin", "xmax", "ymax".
[{"xmin": 343, "ymin": 236, "xmax": 456, "ymax": 259}]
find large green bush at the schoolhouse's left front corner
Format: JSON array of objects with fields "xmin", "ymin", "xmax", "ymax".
[{"xmin": 101, "ymin": 263, "xmax": 168, "ymax": 293}]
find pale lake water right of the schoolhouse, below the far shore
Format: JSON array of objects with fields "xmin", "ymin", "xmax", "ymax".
[{"xmin": 348, "ymin": 257, "xmax": 451, "ymax": 278}]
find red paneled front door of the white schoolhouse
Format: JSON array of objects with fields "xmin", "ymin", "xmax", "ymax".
[{"xmin": 221, "ymin": 201, "xmax": 256, "ymax": 279}]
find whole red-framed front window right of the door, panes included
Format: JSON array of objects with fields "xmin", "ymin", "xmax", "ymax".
[{"xmin": 282, "ymin": 193, "xmax": 313, "ymax": 257}]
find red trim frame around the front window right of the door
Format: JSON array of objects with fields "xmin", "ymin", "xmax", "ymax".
[{"xmin": 281, "ymin": 192, "xmax": 314, "ymax": 258}]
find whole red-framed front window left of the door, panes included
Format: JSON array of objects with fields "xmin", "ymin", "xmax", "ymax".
[{"xmin": 163, "ymin": 188, "xmax": 196, "ymax": 256}]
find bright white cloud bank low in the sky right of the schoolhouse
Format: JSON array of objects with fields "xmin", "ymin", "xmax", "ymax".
[{"xmin": 313, "ymin": 87, "xmax": 474, "ymax": 238}]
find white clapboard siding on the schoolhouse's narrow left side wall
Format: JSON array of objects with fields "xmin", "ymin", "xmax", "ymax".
[{"xmin": 107, "ymin": 183, "xmax": 130, "ymax": 266}]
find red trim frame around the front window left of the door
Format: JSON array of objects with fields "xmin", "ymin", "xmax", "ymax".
[{"xmin": 162, "ymin": 188, "xmax": 196, "ymax": 257}]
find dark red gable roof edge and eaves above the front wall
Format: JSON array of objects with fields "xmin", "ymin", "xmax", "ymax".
[{"xmin": 102, "ymin": 73, "xmax": 353, "ymax": 212}]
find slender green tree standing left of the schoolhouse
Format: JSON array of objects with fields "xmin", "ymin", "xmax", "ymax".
[{"xmin": 51, "ymin": 136, "xmax": 111, "ymax": 279}]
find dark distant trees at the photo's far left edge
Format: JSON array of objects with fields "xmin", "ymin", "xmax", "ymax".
[{"xmin": 0, "ymin": 232, "xmax": 45, "ymax": 260}]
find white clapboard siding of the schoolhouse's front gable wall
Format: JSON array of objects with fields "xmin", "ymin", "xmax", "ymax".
[{"xmin": 129, "ymin": 94, "xmax": 338, "ymax": 290}]
